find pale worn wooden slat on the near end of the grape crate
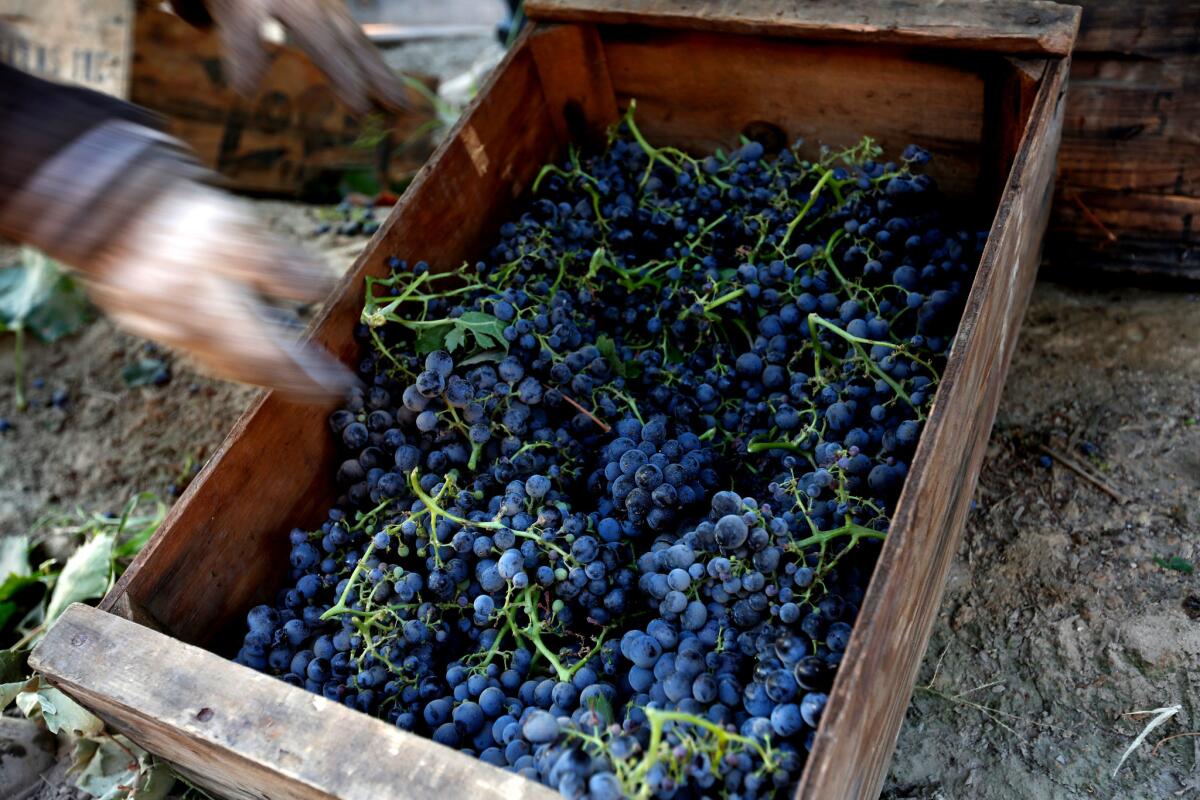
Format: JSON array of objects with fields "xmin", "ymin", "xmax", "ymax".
[{"xmin": 29, "ymin": 603, "xmax": 559, "ymax": 800}]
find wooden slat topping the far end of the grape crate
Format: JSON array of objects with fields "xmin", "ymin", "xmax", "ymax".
[{"xmin": 524, "ymin": 0, "xmax": 1079, "ymax": 55}]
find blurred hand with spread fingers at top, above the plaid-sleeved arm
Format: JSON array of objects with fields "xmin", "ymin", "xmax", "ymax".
[{"xmin": 204, "ymin": 0, "xmax": 409, "ymax": 114}]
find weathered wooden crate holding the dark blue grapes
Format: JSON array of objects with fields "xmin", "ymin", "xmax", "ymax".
[{"xmin": 32, "ymin": 0, "xmax": 1079, "ymax": 800}]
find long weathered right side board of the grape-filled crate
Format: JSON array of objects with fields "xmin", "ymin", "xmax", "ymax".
[{"xmin": 797, "ymin": 61, "xmax": 1067, "ymax": 800}]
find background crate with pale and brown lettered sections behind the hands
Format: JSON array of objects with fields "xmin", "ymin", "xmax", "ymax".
[{"xmin": 0, "ymin": 0, "xmax": 436, "ymax": 196}]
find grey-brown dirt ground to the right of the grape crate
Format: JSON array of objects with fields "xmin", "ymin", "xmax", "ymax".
[{"xmin": 883, "ymin": 283, "xmax": 1200, "ymax": 800}]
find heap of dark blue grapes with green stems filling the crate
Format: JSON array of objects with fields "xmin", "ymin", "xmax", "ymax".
[{"xmin": 238, "ymin": 104, "xmax": 983, "ymax": 800}]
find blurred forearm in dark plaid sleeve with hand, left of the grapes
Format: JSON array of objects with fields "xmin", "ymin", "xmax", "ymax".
[{"xmin": 0, "ymin": 65, "xmax": 354, "ymax": 399}]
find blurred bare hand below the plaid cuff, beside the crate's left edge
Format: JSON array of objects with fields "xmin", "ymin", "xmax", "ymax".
[{"xmin": 84, "ymin": 179, "xmax": 355, "ymax": 399}]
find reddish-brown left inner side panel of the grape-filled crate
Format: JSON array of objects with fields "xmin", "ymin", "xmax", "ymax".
[{"xmin": 110, "ymin": 37, "xmax": 559, "ymax": 644}]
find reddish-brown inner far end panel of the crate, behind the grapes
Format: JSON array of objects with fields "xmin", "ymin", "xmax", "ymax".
[{"xmin": 604, "ymin": 29, "xmax": 996, "ymax": 198}]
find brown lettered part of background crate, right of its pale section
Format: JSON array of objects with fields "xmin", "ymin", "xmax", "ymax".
[{"xmin": 131, "ymin": 0, "xmax": 433, "ymax": 194}]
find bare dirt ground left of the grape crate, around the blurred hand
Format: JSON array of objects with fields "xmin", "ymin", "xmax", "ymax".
[{"xmin": 0, "ymin": 200, "xmax": 362, "ymax": 535}]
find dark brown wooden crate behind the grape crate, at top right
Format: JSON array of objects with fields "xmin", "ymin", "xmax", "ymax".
[{"xmin": 1046, "ymin": 0, "xmax": 1200, "ymax": 284}]
